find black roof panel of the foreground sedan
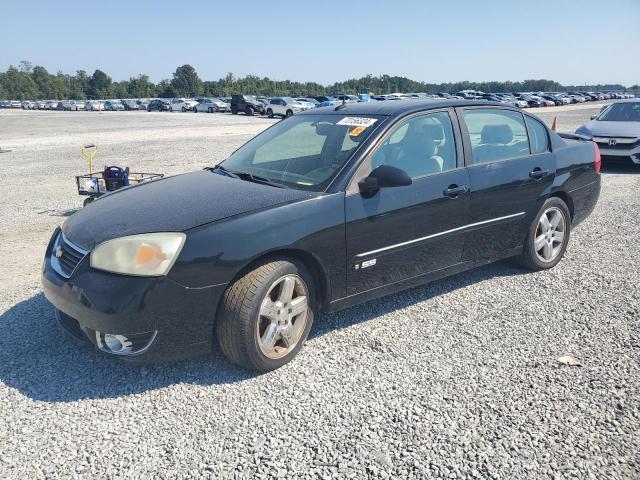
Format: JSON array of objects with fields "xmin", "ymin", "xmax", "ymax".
[{"xmin": 298, "ymin": 98, "xmax": 509, "ymax": 116}]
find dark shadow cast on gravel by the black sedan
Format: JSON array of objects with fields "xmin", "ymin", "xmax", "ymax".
[{"xmin": 0, "ymin": 262, "xmax": 525, "ymax": 403}]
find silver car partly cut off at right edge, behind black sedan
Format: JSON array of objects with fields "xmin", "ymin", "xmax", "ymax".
[{"xmin": 576, "ymin": 99, "xmax": 640, "ymax": 165}]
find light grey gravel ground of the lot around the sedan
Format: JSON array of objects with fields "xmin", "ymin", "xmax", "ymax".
[{"xmin": 0, "ymin": 104, "xmax": 640, "ymax": 479}]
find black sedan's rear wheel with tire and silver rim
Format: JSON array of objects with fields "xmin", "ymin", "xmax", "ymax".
[{"xmin": 519, "ymin": 197, "xmax": 571, "ymax": 270}]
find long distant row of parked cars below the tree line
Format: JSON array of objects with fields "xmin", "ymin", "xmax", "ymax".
[{"xmin": 0, "ymin": 90, "xmax": 634, "ymax": 114}]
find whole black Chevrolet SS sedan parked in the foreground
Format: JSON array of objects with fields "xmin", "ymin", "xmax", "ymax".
[{"xmin": 42, "ymin": 100, "xmax": 600, "ymax": 371}]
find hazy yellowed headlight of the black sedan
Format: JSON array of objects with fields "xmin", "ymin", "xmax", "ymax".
[{"xmin": 91, "ymin": 232, "xmax": 187, "ymax": 277}]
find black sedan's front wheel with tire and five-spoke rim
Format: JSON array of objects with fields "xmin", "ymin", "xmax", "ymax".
[{"xmin": 216, "ymin": 260, "xmax": 315, "ymax": 373}]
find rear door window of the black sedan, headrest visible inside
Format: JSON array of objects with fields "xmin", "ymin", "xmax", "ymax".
[{"xmin": 464, "ymin": 108, "xmax": 529, "ymax": 164}]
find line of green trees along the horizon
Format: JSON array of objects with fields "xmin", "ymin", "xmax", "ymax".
[{"xmin": 0, "ymin": 61, "xmax": 640, "ymax": 100}]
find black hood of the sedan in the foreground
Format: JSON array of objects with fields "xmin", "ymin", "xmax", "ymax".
[{"xmin": 62, "ymin": 170, "xmax": 318, "ymax": 250}]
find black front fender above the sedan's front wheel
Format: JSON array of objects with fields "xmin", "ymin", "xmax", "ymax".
[{"xmin": 169, "ymin": 192, "xmax": 346, "ymax": 298}]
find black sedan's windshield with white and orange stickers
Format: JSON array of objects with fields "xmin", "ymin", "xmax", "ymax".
[{"xmin": 222, "ymin": 114, "xmax": 382, "ymax": 191}]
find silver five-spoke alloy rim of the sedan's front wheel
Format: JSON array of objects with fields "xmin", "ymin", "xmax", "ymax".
[{"xmin": 256, "ymin": 274, "xmax": 309, "ymax": 359}]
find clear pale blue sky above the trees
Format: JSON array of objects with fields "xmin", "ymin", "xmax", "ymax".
[{"xmin": 0, "ymin": 0, "xmax": 640, "ymax": 86}]
